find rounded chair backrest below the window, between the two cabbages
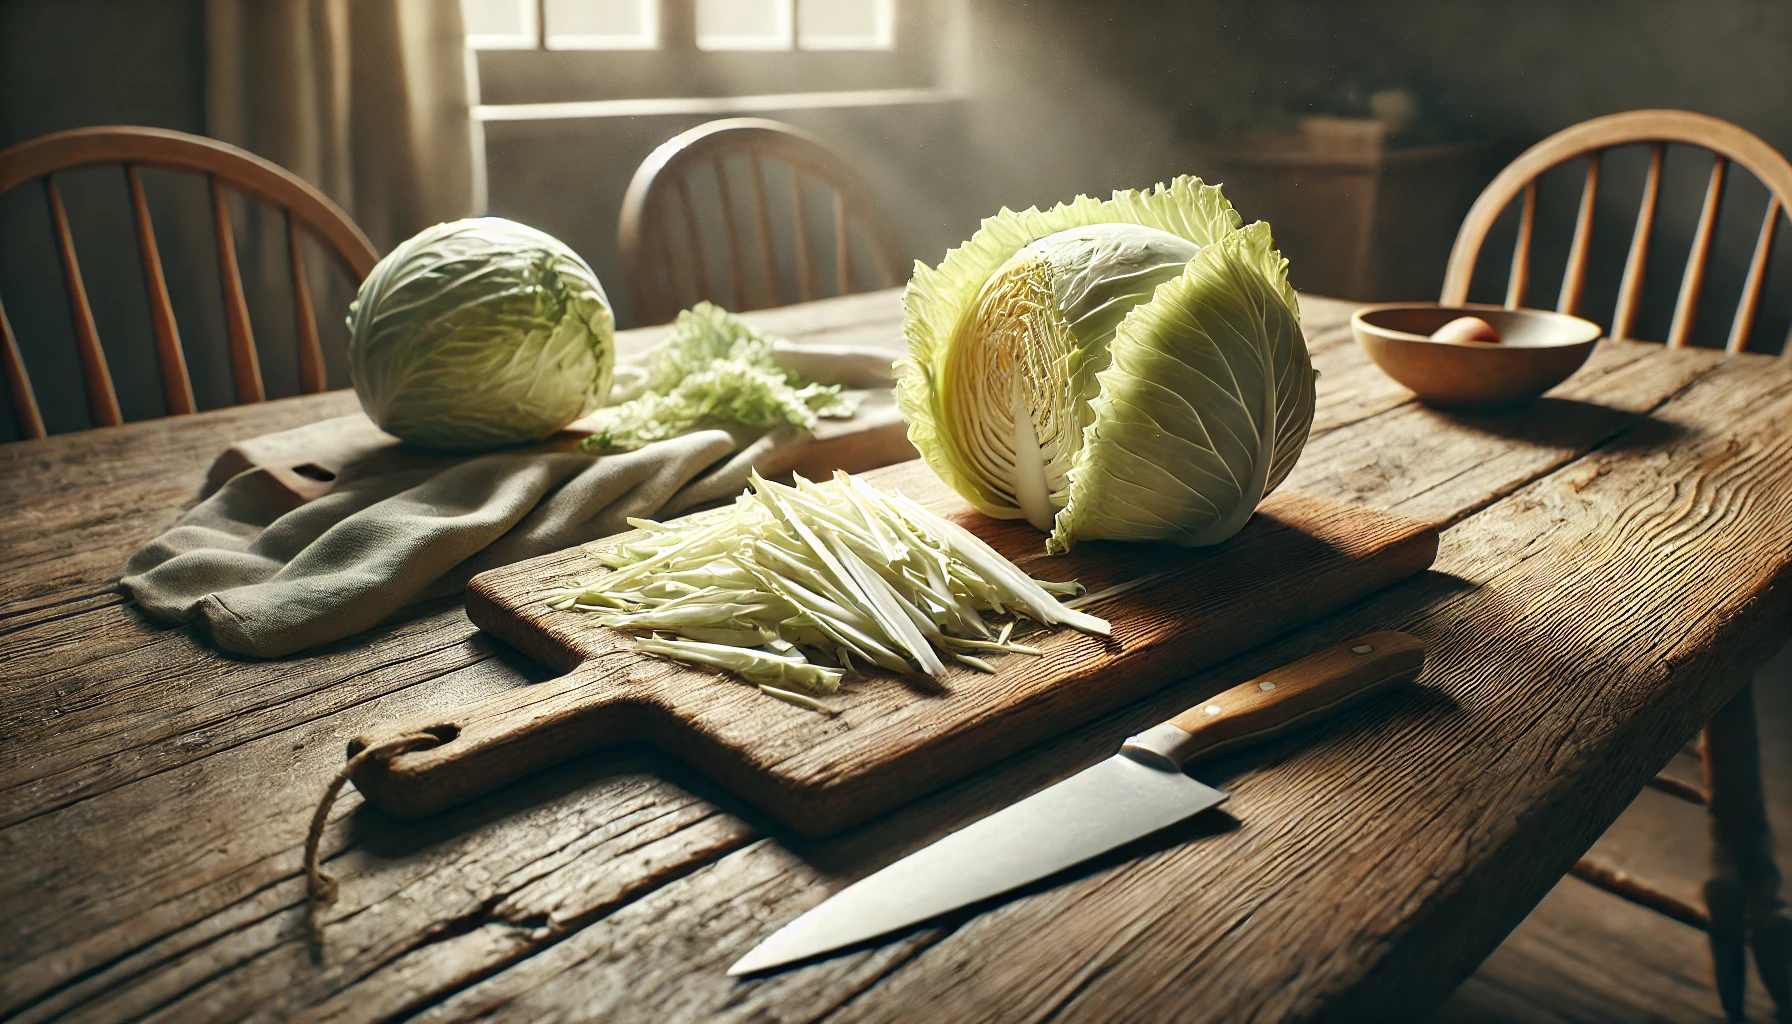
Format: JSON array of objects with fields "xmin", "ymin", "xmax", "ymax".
[{"xmin": 618, "ymin": 117, "xmax": 905, "ymax": 325}]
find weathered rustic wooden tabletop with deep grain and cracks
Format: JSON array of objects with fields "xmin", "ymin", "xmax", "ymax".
[{"xmin": 0, "ymin": 292, "xmax": 1792, "ymax": 1022}]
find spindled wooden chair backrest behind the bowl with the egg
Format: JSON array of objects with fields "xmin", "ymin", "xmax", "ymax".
[{"xmin": 1441, "ymin": 109, "xmax": 1792, "ymax": 357}]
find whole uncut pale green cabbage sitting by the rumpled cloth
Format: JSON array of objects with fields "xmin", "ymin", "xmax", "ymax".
[{"xmin": 348, "ymin": 217, "xmax": 615, "ymax": 448}]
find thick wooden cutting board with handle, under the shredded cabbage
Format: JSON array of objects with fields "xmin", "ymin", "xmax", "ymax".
[{"xmin": 349, "ymin": 461, "xmax": 1437, "ymax": 834}]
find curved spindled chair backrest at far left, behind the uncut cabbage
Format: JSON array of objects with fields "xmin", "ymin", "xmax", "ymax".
[{"xmin": 0, "ymin": 126, "xmax": 378, "ymax": 438}]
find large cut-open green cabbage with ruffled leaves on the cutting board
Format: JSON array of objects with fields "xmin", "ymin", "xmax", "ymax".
[{"xmin": 896, "ymin": 178, "xmax": 1314, "ymax": 551}]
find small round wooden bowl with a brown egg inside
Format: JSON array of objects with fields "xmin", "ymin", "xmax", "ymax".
[{"xmin": 1349, "ymin": 303, "xmax": 1604, "ymax": 409}]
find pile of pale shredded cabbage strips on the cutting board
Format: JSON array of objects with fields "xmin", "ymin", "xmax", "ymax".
[{"xmin": 548, "ymin": 472, "xmax": 1109, "ymax": 710}]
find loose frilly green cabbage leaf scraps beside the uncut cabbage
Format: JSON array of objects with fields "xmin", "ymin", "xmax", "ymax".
[{"xmin": 579, "ymin": 301, "xmax": 858, "ymax": 452}]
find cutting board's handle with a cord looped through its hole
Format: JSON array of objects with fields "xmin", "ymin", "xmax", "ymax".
[{"xmin": 348, "ymin": 655, "xmax": 652, "ymax": 818}]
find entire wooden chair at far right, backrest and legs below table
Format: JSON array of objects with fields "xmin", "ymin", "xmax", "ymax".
[{"xmin": 1441, "ymin": 109, "xmax": 1792, "ymax": 1020}]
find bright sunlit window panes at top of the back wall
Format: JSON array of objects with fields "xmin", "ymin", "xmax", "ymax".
[{"xmin": 461, "ymin": 0, "xmax": 896, "ymax": 52}]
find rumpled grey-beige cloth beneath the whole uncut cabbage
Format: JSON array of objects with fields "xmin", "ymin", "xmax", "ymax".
[{"xmin": 118, "ymin": 350, "xmax": 901, "ymax": 658}]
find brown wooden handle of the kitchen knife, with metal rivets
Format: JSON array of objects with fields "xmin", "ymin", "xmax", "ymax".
[{"xmin": 1122, "ymin": 631, "xmax": 1425, "ymax": 769}]
